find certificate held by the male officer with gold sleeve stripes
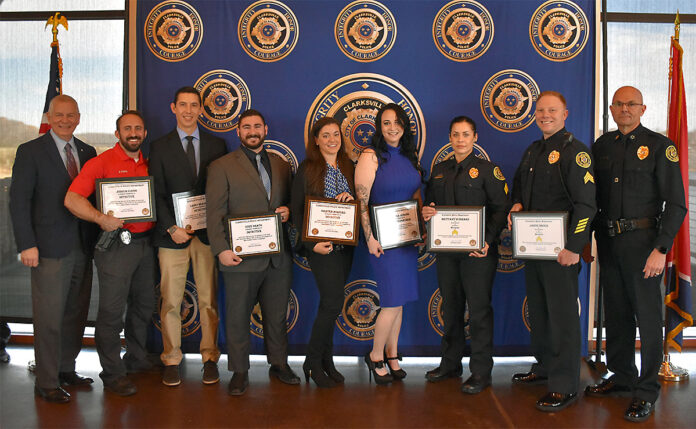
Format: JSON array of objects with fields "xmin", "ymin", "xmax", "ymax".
[{"xmin": 510, "ymin": 211, "xmax": 568, "ymax": 261}]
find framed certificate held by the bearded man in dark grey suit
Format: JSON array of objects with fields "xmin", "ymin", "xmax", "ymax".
[{"xmin": 227, "ymin": 213, "xmax": 283, "ymax": 256}]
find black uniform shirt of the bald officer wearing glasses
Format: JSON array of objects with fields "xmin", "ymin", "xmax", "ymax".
[{"xmin": 592, "ymin": 125, "xmax": 687, "ymax": 249}]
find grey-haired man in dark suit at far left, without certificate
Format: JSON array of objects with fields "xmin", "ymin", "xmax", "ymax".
[{"xmin": 10, "ymin": 95, "xmax": 98, "ymax": 403}]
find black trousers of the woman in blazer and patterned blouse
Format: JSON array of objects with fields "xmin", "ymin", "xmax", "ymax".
[{"xmin": 307, "ymin": 246, "xmax": 354, "ymax": 362}]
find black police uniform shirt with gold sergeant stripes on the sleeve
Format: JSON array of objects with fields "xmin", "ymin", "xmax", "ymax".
[{"xmin": 512, "ymin": 128, "xmax": 597, "ymax": 253}]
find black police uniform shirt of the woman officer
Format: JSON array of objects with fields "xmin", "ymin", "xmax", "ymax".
[{"xmin": 425, "ymin": 152, "xmax": 510, "ymax": 246}]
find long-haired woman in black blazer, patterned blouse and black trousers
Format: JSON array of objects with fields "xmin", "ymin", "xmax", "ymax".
[{"xmin": 290, "ymin": 117, "xmax": 355, "ymax": 387}]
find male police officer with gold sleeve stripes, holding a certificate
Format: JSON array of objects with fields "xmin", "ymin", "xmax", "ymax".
[{"xmin": 508, "ymin": 91, "xmax": 596, "ymax": 411}]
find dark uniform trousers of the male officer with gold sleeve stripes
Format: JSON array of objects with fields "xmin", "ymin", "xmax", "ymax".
[{"xmin": 525, "ymin": 260, "xmax": 581, "ymax": 394}]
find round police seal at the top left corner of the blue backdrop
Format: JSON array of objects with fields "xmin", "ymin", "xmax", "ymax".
[{"xmin": 145, "ymin": 1, "xmax": 203, "ymax": 62}]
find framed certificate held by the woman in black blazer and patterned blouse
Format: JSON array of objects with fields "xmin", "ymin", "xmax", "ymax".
[{"xmin": 302, "ymin": 197, "xmax": 358, "ymax": 246}]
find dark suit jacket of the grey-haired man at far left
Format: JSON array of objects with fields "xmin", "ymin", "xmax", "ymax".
[{"xmin": 10, "ymin": 133, "xmax": 99, "ymax": 258}]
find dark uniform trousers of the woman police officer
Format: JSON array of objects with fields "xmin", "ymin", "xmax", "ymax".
[{"xmin": 437, "ymin": 248, "xmax": 498, "ymax": 377}]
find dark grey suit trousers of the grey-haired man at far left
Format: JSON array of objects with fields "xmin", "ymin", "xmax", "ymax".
[{"xmin": 31, "ymin": 242, "xmax": 92, "ymax": 389}]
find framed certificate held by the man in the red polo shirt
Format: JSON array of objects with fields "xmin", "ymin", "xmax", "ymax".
[{"xmin": 95, "ymin": 176, "xmax": 157, "ymax": 223}]
